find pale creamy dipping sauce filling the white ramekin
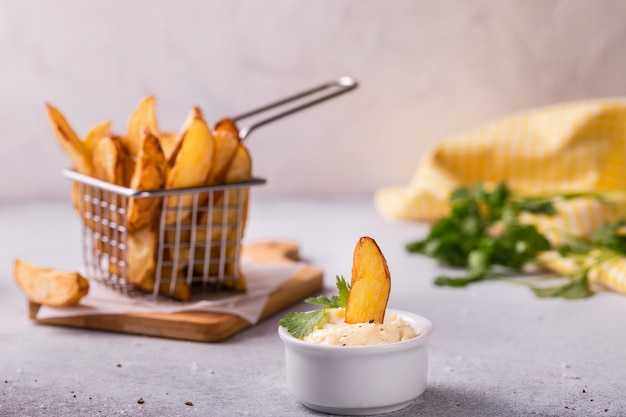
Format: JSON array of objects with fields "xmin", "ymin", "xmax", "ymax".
[{"xmin": 304, "ymin": 308, "xmax": 417, "ymax": 346}]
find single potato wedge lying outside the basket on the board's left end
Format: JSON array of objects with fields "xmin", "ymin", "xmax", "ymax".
[{"xmin": 13, "ymin": 258, "xmax": 89, "ymax": 307}]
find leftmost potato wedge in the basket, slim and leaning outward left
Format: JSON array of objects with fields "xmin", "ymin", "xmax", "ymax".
[{"xmin": 46, "ymin": 104, "xmax": 93, "ymax": 175}]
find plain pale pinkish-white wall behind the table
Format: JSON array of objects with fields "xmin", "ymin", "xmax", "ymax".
[{"xmin": 0, "ymin": 0, "xmax": 626, "ymax": 202}]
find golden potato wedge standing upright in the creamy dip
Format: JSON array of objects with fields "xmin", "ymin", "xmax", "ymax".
[{"xmin": 346, "ymin": 236, "xmax": 391, "ymax": 324}]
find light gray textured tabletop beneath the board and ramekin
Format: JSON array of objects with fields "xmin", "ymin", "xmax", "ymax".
[{"xmin": 0, "ymin": 198, "xmax": 626, "ymax": 417}]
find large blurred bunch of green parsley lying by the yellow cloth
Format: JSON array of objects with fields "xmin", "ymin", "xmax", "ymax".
[{"xmin": 406, "ymin": 183, "xmax": 626, "ymax": 299}]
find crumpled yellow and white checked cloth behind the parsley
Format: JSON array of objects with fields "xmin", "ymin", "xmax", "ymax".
[{"xmin": 375, "ymin": 99, "xmax": 626, "ymax": 293}]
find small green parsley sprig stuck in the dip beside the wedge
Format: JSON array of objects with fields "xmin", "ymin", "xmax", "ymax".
[{"xmin": 278, "ymin": 275, "xmax": 350, "ymax": 339}]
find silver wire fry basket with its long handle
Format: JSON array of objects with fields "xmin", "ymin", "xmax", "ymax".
[{"xmin": 63, "ymin": 77, "xmax": 358, "ymax": 300}]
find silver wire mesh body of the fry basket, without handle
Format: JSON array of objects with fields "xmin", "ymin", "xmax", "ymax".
[{"xmin": 64, "ymin": 171, "xmax": 265, "ymax": 297}]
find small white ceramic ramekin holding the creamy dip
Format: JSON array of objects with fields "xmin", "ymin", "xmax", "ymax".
[{"xmin": 278, "ymin": 309, "xmax": 433, "ymax": 415}]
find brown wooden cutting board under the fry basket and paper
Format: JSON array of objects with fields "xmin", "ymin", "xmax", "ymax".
[{"xmin": 29, "ymin": 242, "xmax": 323, "ymax": 342}]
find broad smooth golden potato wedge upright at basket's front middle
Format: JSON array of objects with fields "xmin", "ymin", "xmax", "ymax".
[{"xmin": 166, "ymin": 108, "xmax": 215, "ymax": 225}]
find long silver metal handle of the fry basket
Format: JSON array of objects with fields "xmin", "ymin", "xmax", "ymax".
[{"xmin": 231, "ymin": 77, "xmax": 359, "ymax": 140}]
